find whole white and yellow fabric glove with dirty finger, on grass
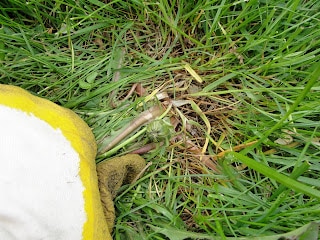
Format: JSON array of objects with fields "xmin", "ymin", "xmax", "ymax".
[{"xmin": 0, "ymin": 84, "xmax": 145, "ymax": 240}]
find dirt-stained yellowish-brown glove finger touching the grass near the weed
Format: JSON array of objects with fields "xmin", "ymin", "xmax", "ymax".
[{"xmin": 97, "ymin": 154, "xmax": 145, "ymax": 232}]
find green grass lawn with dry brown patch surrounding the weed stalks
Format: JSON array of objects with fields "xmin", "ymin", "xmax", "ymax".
[{"xmin": 0, "ymin": 0, "xmax": 320, "ymax": 240}]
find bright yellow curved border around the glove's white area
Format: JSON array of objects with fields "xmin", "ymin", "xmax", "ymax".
[{"xmin": 0, "ymin": 84, "xmax": 111, "ymax": 240}]
